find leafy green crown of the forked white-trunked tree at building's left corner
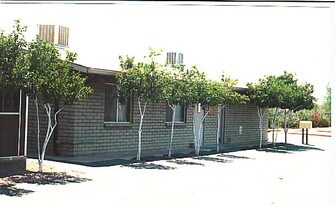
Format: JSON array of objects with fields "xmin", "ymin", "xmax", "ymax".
[{"xmin": 25, "ymin": 38, "xmax": 92, "ymax": 104}]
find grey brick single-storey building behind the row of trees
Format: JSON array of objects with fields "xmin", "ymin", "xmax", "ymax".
[{"xmin": 28, "ymin": 61, "xmax": 267, "ymax": 158}]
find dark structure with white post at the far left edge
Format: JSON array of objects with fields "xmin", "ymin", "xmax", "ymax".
[{"xmin": 0, "ymin": 90, "xmax": 29, "ymax": 176}]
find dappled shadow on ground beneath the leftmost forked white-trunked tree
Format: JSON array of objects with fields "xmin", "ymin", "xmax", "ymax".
[{"xmin": 0, "ymin": 172, "xmax": 91, "ymax": 197}]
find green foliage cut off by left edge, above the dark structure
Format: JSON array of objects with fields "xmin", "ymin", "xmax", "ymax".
[{"xmin": 0, "ymin": 20, "xmax": 28, "ymax": 92}]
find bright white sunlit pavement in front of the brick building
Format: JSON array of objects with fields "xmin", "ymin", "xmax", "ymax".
[{"xmin": 0, "ymin": 129, "xmax": 335, "ymax": 206}]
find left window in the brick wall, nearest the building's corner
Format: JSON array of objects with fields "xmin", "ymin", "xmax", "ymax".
[{"xmin": 105, "ymin": 84, "xmax": 131, "ymax": 122}]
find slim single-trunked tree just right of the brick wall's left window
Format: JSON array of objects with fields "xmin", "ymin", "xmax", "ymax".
[{"xmin": 116, "ymin": 49, "xmax": 164, "ymax": 160}]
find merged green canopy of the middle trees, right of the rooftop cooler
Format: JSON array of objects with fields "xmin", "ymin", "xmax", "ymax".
[{"xmin": 163, "ymin": 65, "xmax": 249, "ymax": 109}]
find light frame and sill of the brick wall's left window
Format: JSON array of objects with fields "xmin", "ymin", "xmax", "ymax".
[{"xmin": 104, "ymin": 82, "xmax": 133, "ymax": 126}]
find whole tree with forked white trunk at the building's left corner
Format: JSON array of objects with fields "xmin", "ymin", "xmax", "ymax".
[{"xmin": 24, "ymin": 38, "xmax": 92, "ymax": 172}]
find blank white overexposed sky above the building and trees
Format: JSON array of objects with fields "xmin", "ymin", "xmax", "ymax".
[{"xmin": 0, "ymin": 1, "xmax": 335, "ymax": 102}]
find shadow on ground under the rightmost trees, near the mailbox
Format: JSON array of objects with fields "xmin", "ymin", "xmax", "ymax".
[{"xmin": 257, "ymin": 144, "xmax": 325, "ymax": 154}]
